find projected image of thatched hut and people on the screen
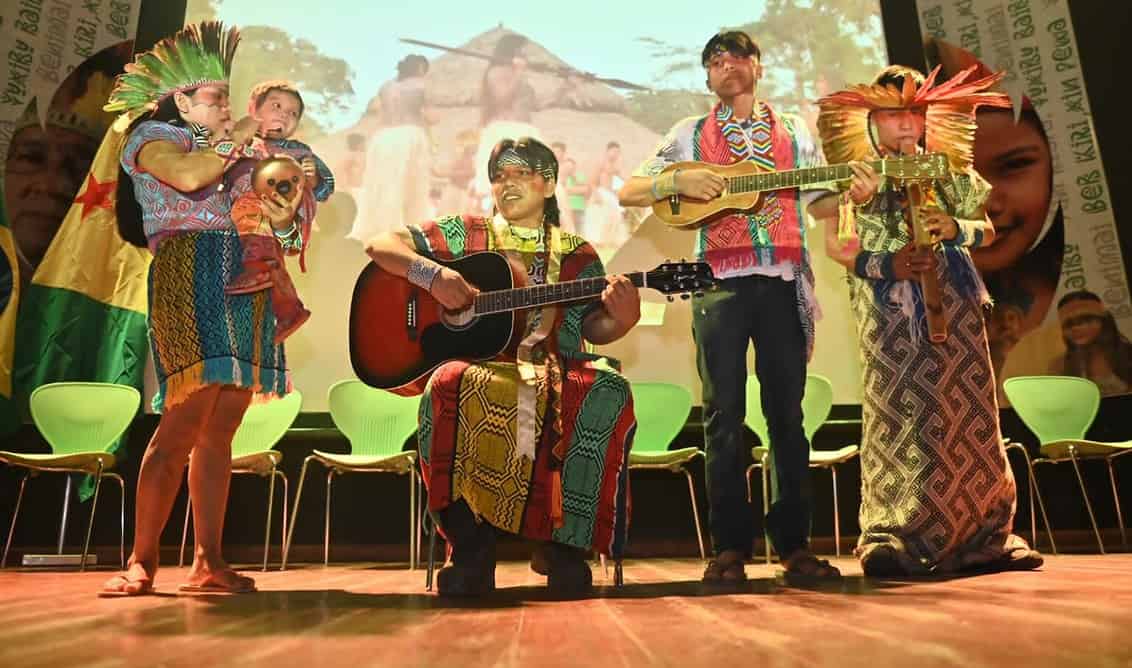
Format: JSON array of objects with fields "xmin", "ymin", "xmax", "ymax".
[{"xmin": 186, "ymin": 0, "xmax": 886, "ymax": 410}]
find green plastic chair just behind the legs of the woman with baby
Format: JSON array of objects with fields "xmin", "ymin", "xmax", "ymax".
[{"xmin": 180, "ymin": 389, "xmax": 302, "ymax": 571}]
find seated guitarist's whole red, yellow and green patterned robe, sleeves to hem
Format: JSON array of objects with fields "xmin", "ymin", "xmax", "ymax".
[{"xmin": 410, "ymin": 216, "xmax": 636, "ymax": 558}]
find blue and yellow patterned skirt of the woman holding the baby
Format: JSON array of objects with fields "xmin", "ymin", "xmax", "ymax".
[{"xmin": 148, "ymin": 230, "xmax": 290, "ymax": 412}]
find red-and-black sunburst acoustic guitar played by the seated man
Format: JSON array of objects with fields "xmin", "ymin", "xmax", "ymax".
[{"xmin": 350, "ymin": 251, "xmax": 714, "ymax": 396}]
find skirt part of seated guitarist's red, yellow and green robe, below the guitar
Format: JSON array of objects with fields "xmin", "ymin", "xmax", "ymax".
[{"xmin": 419, "ymin": 361, "xmax": 636, "ymax": 558}]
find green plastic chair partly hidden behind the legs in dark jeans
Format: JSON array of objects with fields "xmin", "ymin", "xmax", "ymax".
[{"xmin": 745, "ymin": 374, "xmax": 860, "ymax": 564}]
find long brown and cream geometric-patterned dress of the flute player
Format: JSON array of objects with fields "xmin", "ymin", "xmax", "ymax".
[{"xmin": 849, "ymin": 172, "xmax": 1026, "ymax": 574}]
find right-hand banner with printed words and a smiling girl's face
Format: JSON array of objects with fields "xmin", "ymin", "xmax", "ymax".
[{"xmin": 917, "ymin": 0, "xmax": 1132, "ymax": 395}]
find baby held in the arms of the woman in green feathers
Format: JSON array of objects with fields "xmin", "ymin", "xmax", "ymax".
[{"xmin": 226, "ymin": 80, "xmax": 334, "ymax": 343}]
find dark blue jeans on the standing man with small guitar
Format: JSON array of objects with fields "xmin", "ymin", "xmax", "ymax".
[{"xmin": 692, "ymin": 275, "xmax": 813, "ymax": 557}]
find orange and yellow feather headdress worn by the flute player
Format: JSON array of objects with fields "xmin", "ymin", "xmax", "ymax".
[{"xmin": 817, "ymin": 67, "xmax": 1011, "ymax": 172}]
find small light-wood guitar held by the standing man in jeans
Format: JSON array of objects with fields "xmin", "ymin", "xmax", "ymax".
[{"xmin": 652, "ymin": 153, "xmax": 947, "ymax": 230}]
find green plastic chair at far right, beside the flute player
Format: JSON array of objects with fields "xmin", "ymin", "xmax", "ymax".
[{"xmin": 1003, "ymin": 376, "xmax": 1132, "ymax": 554}]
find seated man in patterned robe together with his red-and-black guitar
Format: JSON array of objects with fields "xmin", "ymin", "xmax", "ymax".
[{"xmin": 366, "ymin": 138, "xmax": 649, "ymax": 596}]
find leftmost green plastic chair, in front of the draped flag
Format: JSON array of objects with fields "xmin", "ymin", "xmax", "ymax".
[{"xmin": 0, "ymin": 383, "xmax": 142, "ymax": 571}]
